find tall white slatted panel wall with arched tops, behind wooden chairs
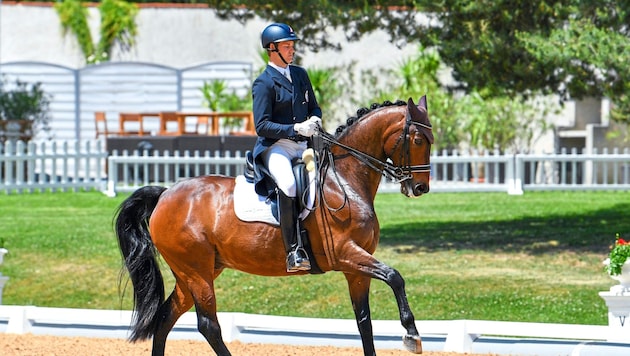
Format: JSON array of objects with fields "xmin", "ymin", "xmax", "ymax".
[{"xmin": 0, "ymin": 60, "xmax": 253, "ymax": 140}]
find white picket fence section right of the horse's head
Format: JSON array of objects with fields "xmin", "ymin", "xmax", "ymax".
[{"xmin": 431, "ymin": 148, "xmax": 630, "ymax": 194}]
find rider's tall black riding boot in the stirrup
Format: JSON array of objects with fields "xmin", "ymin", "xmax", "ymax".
[{"xmin": 278, "ymin": 189, "xmax": 311, "ymax": 272}]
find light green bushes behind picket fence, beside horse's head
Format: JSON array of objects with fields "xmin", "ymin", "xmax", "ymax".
[{"xmin": 374, "ymin": 48, "xmax": 556, "ymax": 152}]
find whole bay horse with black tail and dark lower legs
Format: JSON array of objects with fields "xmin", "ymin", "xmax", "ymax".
[{"xmin": 115, "ymin": 96, "xmax": 433, "ymax": 356}]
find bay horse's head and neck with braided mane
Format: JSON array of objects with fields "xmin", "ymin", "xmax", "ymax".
[{"xmin": 320, "ymin": 96, "xmax": 433, "ymax": 197}]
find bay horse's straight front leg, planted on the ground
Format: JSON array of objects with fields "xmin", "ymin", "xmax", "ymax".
[{"xmin": 344, "ymin": 273, "xmax": 376, "ymax": 356}]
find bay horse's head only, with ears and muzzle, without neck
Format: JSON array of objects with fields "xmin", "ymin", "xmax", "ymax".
[{"xmin": 385, "ymin": 96, "xmax": 433, "ymax": 197}]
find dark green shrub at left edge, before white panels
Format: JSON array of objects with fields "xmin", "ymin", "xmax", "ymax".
[{"xmin": 0, "ymin": 79, "xmax": 50, "ymax": 143}]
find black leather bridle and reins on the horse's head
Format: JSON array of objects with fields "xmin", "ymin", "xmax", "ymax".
[{"xmin": 319, "ymin": 115, "xmax": 432, "ymax": 183}]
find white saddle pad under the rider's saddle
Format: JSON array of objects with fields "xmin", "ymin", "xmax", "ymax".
[{"xmin": 234, "ymin": 172, "xmax": 316, "ymax": 225}]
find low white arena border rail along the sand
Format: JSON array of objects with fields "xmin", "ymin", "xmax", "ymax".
[{"xmin": 0, "ymin": 305, "xmax": 630, "ymax": 355}]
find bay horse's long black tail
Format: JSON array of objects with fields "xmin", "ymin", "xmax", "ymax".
[{"xmin": 115, "ymin": 186, "xmax": 166, "ymax": 341}]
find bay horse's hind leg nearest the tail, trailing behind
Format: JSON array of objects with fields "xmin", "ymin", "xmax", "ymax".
[{"xmin": 151, "ymin": 280, "xmax": 193, "ymax": 356}]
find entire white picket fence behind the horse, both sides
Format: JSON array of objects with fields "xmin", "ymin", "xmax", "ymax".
[{"xmin": 0, "ymin": 140, "xmax": 630, "ymax": 196}]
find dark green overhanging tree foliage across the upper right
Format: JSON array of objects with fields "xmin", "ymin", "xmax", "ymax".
[{"xmin": 201, "ymin": 0, "xmax": 630, "ymax": 125}]
